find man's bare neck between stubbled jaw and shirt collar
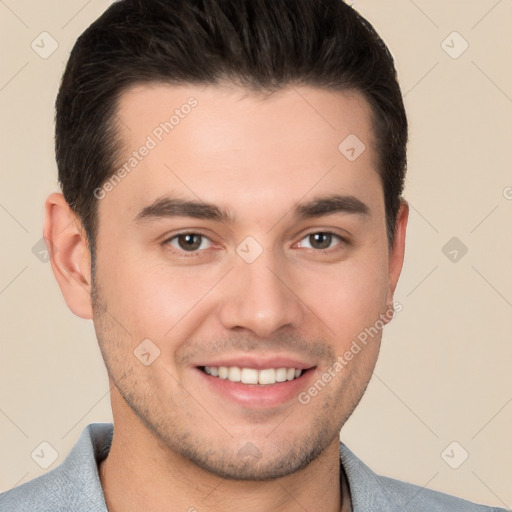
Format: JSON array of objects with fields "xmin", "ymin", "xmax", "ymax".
[{"xmin": 100, "ymin": 421, "xmax": 343, "ymax": 512}]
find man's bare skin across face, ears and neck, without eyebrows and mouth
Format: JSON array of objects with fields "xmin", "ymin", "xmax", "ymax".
[{"xmin": 44, "ymin": 83, "xmax": 408, "ymax": 512}]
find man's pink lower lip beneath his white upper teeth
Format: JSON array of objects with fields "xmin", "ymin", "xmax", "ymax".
[{"xmin": 196, "ymin": 368, "xmax": 315, "ymax": 408}]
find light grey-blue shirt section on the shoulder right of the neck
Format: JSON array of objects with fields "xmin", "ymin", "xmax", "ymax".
[{"xmin": 340, "ymin": 443, "xmax": 505, "ymax": 512}]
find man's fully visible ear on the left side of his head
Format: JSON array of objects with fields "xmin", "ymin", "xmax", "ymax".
[{"xmin": 43, "ymin": 193, "xmax": 92, "ymax": 319}]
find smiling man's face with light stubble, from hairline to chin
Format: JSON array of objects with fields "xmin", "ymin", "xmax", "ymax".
[{"xmin": 92, "ymin": 84, "xmax": 401, "ymax": 480}]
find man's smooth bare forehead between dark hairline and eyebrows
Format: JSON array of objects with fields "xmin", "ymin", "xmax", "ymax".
[{"xmin": 100, "ymin": 84, "xmax": 382, "ymax": 226}]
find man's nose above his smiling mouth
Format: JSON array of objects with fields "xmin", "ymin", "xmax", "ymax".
[{"xmin": 219, "ymin": 251, "xmax": 304, "ymax": 338}]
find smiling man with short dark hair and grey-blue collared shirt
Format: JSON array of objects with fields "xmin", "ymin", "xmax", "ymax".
[{"xmin": 0, "ymin": 0, "xmax": 504, "ymax": 512}]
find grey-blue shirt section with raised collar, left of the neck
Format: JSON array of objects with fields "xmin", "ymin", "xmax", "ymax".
[{"xmin": 0, "ymin": 423, "xmax": 113, "ymax": 512}]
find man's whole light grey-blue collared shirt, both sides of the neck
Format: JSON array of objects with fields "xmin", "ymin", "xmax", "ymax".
[{"xmin": 0, "ymin": 423, "xmax": 505, "ymax": 512}]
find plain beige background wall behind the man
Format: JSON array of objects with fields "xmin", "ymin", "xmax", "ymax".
[{"xmin": 0, "ymin": 0, "xmax": 512, "ymax": 507}]
